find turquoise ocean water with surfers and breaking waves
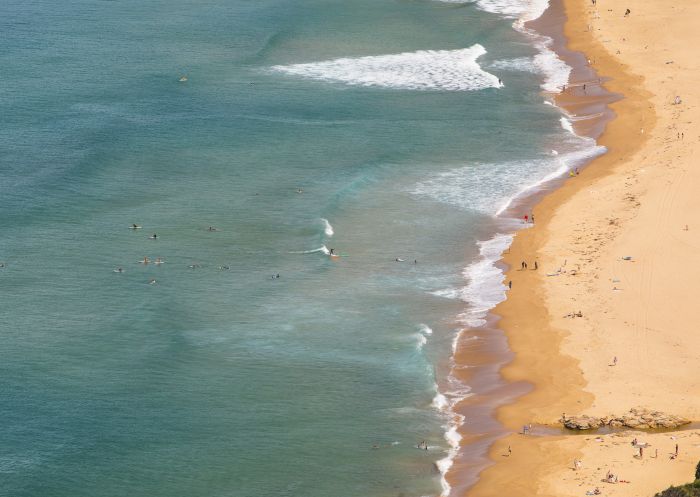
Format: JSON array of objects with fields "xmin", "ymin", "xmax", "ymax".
[{"xmin": 0, "ymin": 0, "xmax": 591, "ymax": 497}]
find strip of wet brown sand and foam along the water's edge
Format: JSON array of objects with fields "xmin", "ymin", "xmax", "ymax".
[{"xmin": 440, "ymin": 0, "xmax": 622, "ymax": 497}]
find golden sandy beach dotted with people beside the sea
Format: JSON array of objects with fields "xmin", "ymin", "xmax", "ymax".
[{"xmin": 456, "ymin": 0, "xmax": 700, "ymax": 497}]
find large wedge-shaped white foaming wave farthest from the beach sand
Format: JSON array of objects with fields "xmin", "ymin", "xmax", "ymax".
[{"xmin": 272, "ymin": 44, "xmax": 502, "ymax": 91}]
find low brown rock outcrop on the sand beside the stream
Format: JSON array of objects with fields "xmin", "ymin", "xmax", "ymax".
[{"xmin": 561, "ymin": 407, "xmax": 690, "ymax": 430}]
